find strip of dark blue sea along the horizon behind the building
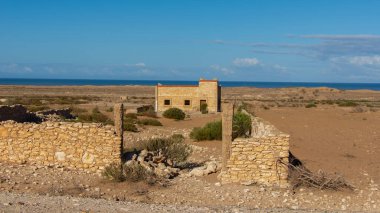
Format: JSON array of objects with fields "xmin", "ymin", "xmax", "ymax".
[{"xmin": 0, "ymin": 78, "xmax": 380, "ymax": 91}]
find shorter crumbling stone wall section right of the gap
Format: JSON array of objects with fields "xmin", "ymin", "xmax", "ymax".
[{"xmin": 220, "ymin": 110, "xmax": 289, "ymax": 188}]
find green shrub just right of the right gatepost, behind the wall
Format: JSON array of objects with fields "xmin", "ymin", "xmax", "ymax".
[{"xmin": 232, "ymin": 112, "xmax": 252, "ymax": 139}]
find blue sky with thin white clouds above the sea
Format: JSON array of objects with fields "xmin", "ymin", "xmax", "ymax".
[{"xmin": 0, "ymin": 0, "xmax": 380, "ymax": 83}]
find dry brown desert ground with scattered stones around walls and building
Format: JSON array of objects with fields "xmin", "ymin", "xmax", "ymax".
[{"xmin": 0, "ymin": 86, "xmax": 380, "ymax": 212}]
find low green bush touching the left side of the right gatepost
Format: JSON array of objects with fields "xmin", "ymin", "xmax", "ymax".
[{"xmin": 190, "ymin": 121, "xmax": 222, "ymax": 141}]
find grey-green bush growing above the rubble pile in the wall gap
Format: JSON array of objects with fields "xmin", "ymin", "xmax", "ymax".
[{"xmin": 140, "ymin": 135, "xmax": 192, "ymax": 163}]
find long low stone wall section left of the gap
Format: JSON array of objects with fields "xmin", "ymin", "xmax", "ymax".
[{"xmin": 0, "ymin": 121, "xmax": 122, "ymax": 172}]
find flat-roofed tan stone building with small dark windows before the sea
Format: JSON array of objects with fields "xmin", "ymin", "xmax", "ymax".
[{"xmin": 155, "ymin": 79, "xmax": 221, "ymax": 113}]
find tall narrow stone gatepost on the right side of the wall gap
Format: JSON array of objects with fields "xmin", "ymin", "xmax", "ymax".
[{"xmin": 222, "ymin": 103, "xmax": 234, "ymax": 170}]
